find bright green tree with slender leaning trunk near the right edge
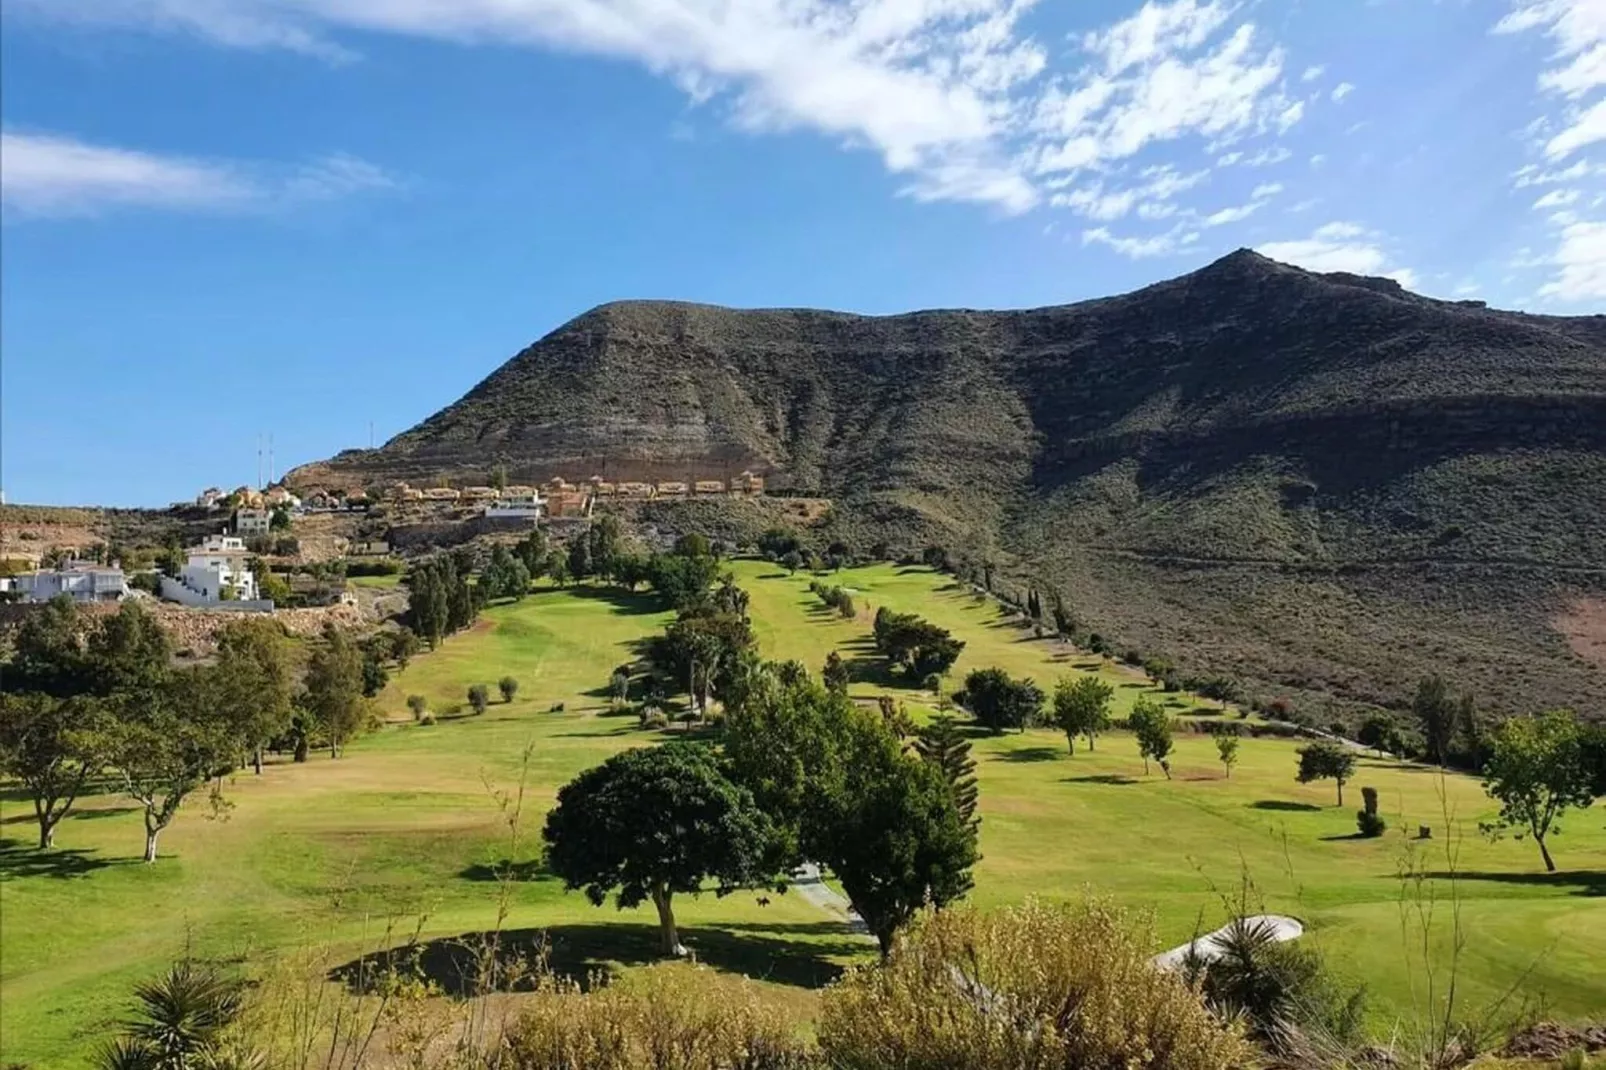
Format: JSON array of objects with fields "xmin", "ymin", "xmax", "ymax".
[{"xmin": 1484, "ymin": 710, "xmax": 1595, "ymax": 872}]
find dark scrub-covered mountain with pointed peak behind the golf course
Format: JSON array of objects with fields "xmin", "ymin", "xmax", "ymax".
[{"xmin": 291, "ymin": 251, "xmax": 1606, "ymax": 712}]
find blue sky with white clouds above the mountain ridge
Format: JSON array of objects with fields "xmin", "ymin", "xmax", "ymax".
[{"xmin": 0, "ymin": 0, "xmax": 1606, "ymax": 504}]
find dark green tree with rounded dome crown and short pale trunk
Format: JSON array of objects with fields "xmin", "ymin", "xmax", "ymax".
[{"xmin": 544, "ymin": 742, "xmax": 772, "ymax": 956}]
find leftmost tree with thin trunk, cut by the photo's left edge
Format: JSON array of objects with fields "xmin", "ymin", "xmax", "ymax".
[{"xmin": 0, "ymin": 692, "xmax": 104, "ymax": 850}]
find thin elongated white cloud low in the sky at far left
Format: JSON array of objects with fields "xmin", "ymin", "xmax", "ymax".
[{"xmin": 0, "ymin": 130, "xmax": 395, "ymax": 217}]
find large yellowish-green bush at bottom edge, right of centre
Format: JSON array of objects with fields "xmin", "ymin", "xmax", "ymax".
[{"xmin": 819, "ymin": 900, "xmax": 1253, "ymax": 1070}]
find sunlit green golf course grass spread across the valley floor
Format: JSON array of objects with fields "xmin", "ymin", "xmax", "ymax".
[{"xmin": 0, "ymin": 562, "xmax": 1606, "ymax": 1067}]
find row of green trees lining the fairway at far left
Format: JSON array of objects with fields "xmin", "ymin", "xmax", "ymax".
[{"xmin": 0, "ymin": 598, "xmax": 369, "ymax": 861}]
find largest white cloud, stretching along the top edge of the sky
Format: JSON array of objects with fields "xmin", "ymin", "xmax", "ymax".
[{"xmin": 8, "ymin": 0, "xmax": 1302, "ymax": 212}]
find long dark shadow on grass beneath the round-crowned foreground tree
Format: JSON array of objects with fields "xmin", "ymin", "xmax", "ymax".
[{"xmin": 329, "ymin": 922, "xmax": 866, "ymax": 996}]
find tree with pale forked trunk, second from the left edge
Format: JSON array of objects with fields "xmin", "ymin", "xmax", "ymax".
[{"xmin": 108, "ymin": 667, "xmax": 239, "ymax": 863}]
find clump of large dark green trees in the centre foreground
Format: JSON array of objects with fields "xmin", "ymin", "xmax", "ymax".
[{"xmin": 544, "ymin": 659, "xmax": 978, "ymax": 954}]
